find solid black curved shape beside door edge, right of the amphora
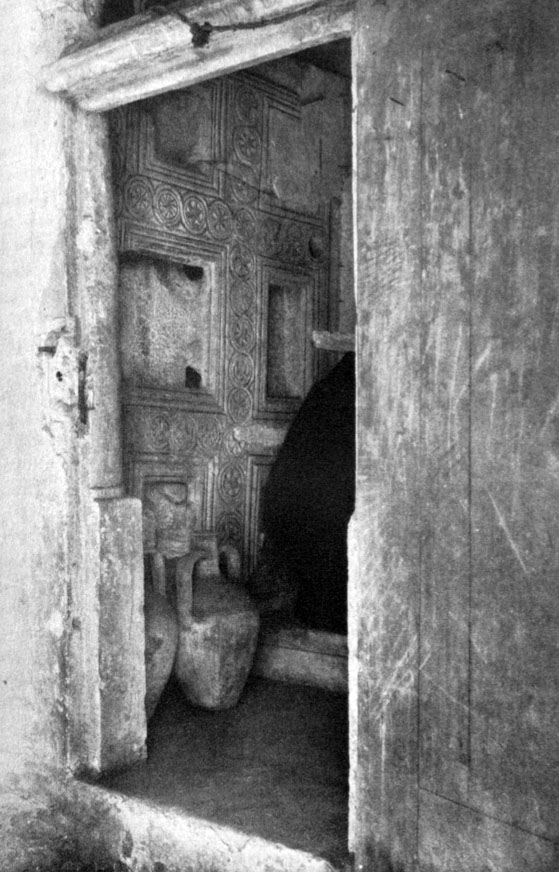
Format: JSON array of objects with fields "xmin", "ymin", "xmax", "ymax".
[{"xmin": 250, "ymin": 352, "xmax": 355, "ymax": 633}]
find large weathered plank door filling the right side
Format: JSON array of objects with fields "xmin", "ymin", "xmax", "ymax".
[{"xmin": 350, "ymin": 2, "xmax": 559, "ymax": 872}]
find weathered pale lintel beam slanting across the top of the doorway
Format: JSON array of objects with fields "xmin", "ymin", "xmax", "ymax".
[{"xmin": 44, "ymin": 0, "xmax": 353, "ymax": 112}]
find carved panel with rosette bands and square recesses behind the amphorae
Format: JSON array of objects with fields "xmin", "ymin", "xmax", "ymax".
[{"xmin": 112, "ymin": 74, "xmax": 329, "ymax": 569}]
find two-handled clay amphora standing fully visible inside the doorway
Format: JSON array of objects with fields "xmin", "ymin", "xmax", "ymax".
[{"xmin": 175, "ymin": 536, "xmax": 259, "ymax": 709}]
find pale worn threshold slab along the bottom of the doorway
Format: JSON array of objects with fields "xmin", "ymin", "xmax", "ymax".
[{"xmin": 68, "ymin": 781, "xmax": 343, "ymax": 872}]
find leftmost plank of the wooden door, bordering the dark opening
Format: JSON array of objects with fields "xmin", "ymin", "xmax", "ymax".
[{"xmin": 349, "ymin": 0, "xmax": 421, "ymax": 869}]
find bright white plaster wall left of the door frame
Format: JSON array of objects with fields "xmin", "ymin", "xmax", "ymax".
[{"xmin": 0, "ymin": 3, "xmax": 83, "ymax": 860}]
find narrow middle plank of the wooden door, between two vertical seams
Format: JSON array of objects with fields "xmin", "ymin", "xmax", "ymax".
[{"xmin": 418, "ymin": 15, "xmax": 472, "ymax": 799}]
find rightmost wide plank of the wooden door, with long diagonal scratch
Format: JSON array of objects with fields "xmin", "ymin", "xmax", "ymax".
[{"xmin": 470, "ymin": 0, "xmax": 559, "ymax": 844}]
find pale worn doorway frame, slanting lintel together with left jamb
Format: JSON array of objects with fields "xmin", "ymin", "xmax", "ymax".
[{"xmin": 44, "ymin": 0, "xmax": 358, "ymax": 845}]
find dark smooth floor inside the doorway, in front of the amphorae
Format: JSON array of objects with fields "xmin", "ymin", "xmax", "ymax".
[{"xmin": 104, "ymin": 678, "xmax": 348, "ymax": 868}]
